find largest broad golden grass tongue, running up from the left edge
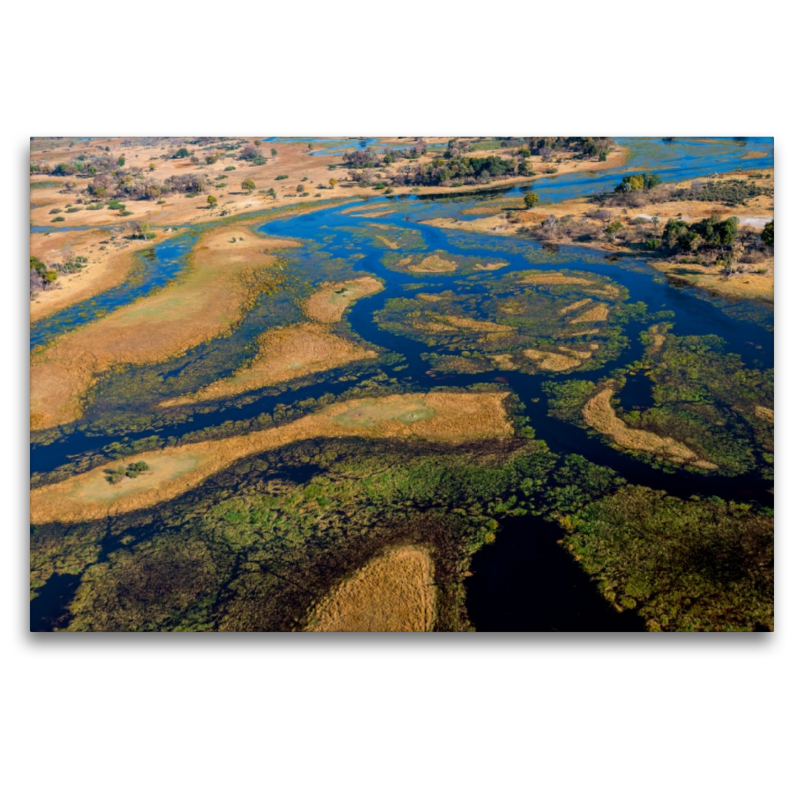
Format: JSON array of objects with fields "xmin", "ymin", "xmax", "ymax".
[{"xmin": 31, "ymin": 227, "xmax": 294, "ymax": 430}]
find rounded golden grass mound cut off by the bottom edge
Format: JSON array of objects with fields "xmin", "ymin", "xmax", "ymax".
[{"xmin": 306, "ymin": 545, "xmax": 436, "ymax": 633}]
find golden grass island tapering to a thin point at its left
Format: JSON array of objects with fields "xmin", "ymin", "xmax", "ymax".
[{"xmin": 160, "ymin": 322, "xmax": 378, "ymax": 407}]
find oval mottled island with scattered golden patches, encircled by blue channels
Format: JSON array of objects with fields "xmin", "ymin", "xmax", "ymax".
[{"xmin": 375, "ymin": 270, "xmax": 643, "ymax": 374}]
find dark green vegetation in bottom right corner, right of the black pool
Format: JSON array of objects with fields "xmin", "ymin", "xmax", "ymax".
[{"xmin": 562, "ymin": 486, "xmax": 774, "ymax": 631}]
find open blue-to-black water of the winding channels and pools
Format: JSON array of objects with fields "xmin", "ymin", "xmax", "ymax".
[{"xmin": 31, "ymin": 139, "xmax": 773, "ymax": 631}]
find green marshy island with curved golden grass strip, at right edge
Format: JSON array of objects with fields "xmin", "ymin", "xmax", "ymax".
[{"xmin": 544, "ymin": 324, "xmax": 774, "ymax": 479}]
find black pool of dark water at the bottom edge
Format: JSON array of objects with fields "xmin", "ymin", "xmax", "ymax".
[{"xmin": 465, "ymin": 517, "xmax": 644, "ymax": 633}]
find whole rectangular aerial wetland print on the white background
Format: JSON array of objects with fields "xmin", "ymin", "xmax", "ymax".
[{"xmin": 30, "ymin": 136, "xmax": 775, "ymax": 632}]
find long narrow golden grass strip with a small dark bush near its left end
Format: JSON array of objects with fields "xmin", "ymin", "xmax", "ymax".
[{"xmin": 31, "ymin": 392, "xmax": 513, "ymax": 524}]
